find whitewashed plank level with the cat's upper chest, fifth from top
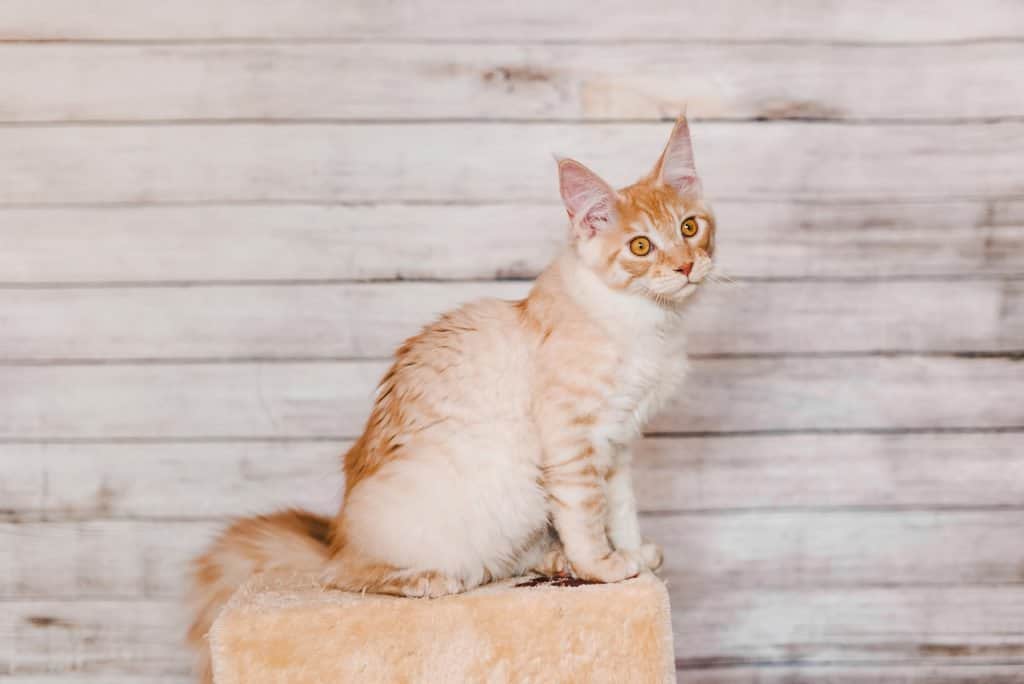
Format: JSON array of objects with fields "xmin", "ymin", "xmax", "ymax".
[{"xmin": 0, "ymin": 279, "xmax": 1024, "ymax": 362}]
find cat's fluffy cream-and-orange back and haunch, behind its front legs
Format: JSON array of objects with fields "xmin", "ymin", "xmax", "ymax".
[{"xmin": 340, "ymin": 299, "xmax": 547, "ymax": 585}]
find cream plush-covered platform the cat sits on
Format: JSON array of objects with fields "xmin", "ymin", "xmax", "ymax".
[{"xmin": 210, "ymin": 574, "xmax": 675, "ymax": 684}]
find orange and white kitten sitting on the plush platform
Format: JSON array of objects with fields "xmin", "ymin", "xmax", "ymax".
[{"xmin": 189, "ymin": 116, "xmax": 715, "ymax": 678}]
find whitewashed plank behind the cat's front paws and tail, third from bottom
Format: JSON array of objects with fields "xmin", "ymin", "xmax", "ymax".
[{"xmin": 8, "ymin": 511, "xmax": 1024, "ymax": 611}]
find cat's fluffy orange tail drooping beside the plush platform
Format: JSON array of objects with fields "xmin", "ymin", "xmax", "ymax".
[{"xmin": 188, "ymin": 509, "xmax": 331, "ymax": 683}]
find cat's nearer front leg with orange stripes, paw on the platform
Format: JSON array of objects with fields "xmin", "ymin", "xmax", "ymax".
[{"xmin": 544, "ymin": 441, "xmax": 641, "ymax": 582}]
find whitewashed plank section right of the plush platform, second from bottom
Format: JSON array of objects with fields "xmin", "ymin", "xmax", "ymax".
[{"xmin": 670, "ymin": 586, "xmax": 1024, "ymax": 663}]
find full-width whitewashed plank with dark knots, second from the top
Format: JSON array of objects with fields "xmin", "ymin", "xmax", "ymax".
[{"xmin": 0, "ymin": 41, "xmax": 1024, "ymax": 122}]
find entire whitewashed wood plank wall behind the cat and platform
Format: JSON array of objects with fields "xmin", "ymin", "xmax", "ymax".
[{"xmin": 0, "ymin": 0, "xmax": 1024, "ymax": 684}]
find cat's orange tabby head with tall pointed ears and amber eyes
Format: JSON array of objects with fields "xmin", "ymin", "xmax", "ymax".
[{"xmin": 558, "ymin": 117, "xmax": 715, "ymax": 304}]
